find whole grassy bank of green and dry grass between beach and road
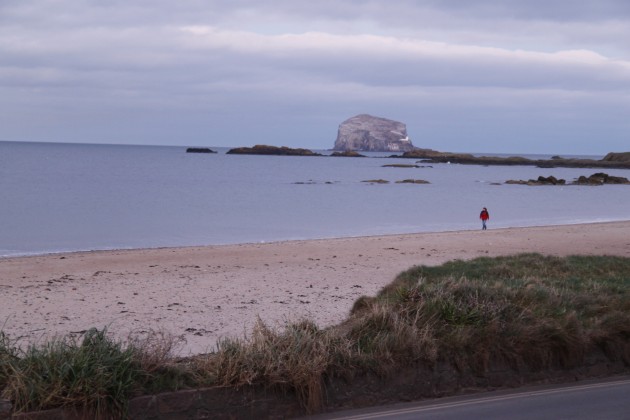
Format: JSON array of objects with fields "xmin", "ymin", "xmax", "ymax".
[{"xmin": 0, "ymin": 254, "xmax": 630, "ymax": 414}]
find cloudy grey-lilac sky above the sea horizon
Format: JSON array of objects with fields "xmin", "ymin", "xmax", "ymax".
[{"xmin": 0, "ymin": 0, "xmax": 630, "ymax": 155}]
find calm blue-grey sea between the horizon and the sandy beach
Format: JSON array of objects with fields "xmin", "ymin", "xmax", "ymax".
[{"xmin": 0, "ymin": 142, "xmax": 630, "ymax": 257}]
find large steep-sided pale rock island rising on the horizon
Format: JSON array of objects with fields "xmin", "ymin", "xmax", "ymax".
[{"xmin": 333, "ymin": 114, "xmax": 414, "ymax": 152}]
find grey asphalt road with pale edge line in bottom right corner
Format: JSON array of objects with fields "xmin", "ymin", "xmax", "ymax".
[{"xmin": 309, "ymin": 376, "xmax": 630, "ymax": 420}]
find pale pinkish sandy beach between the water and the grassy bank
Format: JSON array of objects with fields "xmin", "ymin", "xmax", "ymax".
[{"xmin": 0, "ymin": 222, "xmax": 630, "ymax": 356}]
